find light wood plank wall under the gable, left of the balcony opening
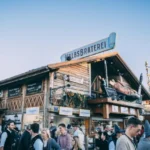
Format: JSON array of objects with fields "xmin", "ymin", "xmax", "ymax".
[{"xmin": 53, "ymin": 63, "xmax": 90, "ymax": 97}]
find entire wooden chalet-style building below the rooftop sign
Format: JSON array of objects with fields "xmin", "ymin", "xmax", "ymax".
[{"xmin": 0, "ymin": 52, "xmax": 150, "ymax": 134}]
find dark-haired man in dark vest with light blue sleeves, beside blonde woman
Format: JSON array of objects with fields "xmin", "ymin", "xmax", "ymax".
[{"xmin": 29, "ymin": 123, "xmax": 43, "ymax": 150}]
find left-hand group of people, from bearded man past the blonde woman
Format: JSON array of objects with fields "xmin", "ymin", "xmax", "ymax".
[{"xmin": 0, "ymin": 121, "xmax": 85, "ymax": 150}]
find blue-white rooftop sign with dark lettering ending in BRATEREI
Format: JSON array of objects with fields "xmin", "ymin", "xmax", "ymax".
[{"xmin": 61, "ymin": 33, "xmax": 116, "ymax": 61}]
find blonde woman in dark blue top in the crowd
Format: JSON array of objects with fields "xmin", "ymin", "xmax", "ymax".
[{"xmin": 41, "ymin": 128, "xmax": 60, "ymax": 150}]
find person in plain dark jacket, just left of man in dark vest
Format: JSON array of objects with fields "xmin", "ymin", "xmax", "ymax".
[{"xmin": 18, "ymin": 125, "xmax": 31, "ymax": 150}]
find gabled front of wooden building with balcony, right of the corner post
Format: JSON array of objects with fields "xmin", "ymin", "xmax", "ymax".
[{"xmin": 48, "ymin": 52, "xmax": 150, "ymax": 133}]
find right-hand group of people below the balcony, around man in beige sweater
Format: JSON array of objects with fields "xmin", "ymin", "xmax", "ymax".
[{"xmin": 95, "ymin": 117, "xmax": 150, "ymax": 150}]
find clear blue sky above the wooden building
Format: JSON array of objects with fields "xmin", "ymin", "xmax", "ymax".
[{"xmin": 0, "ymin": 0, "xmax": 150, "ymax": 86}]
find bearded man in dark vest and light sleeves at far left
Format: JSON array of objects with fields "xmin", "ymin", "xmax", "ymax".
[{"xmin": 0, "ymin": 120, "xmax": 15, "ymax": 150}]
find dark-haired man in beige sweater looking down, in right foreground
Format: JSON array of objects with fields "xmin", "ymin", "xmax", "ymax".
[{"xmin": 116, "ymin": 117, "xmax": 142, "ymax": 150}]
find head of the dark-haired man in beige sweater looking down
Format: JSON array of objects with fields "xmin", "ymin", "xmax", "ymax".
[{"xmin": 126, "ymin": 117, "xmax": 142, "ymax": 137}]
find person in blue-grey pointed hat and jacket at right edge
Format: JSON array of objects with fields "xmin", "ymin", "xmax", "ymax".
[{"xmin": 138, "ymin": 120, "xmax": 150, "ymax": 150}]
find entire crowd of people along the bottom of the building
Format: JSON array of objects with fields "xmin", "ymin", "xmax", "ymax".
[{"xmin": 0, "ymin": 117, "xmax": 150, "ymax": 150}]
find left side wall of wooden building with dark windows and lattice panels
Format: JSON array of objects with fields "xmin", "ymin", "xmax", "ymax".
[{"xmin": 0, "ymin": 66, "xmax": 49, "ymax": 129}]
